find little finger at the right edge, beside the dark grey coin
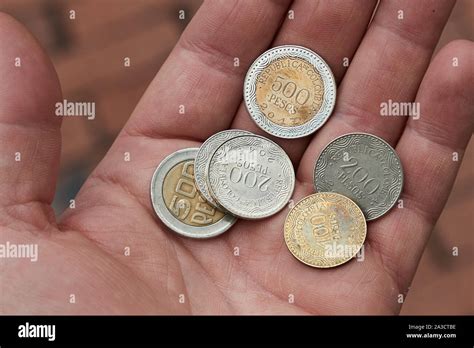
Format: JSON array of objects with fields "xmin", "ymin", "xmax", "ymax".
[{"xmin": 368, "ymin": 41, "xmax": 474, "ymax": 291}]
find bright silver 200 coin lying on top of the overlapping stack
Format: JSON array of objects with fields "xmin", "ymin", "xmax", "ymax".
[{"xmin": 206, "ymin": 135, "xmax": 295, "ymax": 219}]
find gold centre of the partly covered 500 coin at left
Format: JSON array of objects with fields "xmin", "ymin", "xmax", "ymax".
[{"xmin": 163, "ymin": 160, "xmax": 225, "ymax": 227}]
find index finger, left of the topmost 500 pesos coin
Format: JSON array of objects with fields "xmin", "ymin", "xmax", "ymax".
[{"xmin": 125, "ymin": 0, "xmax": 290, "ymax": 140}]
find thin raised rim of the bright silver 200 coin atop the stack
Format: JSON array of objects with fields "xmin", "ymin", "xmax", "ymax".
[{"xmin": 206, "ymin": 134, "xmax": 296, "ymax": 220}]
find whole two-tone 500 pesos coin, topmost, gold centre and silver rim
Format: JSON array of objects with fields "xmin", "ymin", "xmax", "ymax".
[{"xmin": 244, "ymin": 45, "xmax": 336, "ymax": 138}]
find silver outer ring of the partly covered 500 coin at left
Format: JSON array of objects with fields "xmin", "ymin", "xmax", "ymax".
[{"xmin": 150, "ymin": 148, "xmax": 237, "ymax": 239}]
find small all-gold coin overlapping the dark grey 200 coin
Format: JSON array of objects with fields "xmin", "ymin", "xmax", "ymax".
[{"xmin": 284, "ymin": 192, "xmax": 367, "ymax": 268}]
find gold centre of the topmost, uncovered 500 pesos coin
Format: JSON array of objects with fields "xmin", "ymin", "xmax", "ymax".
[{"xmin": 256, "ymin": 57, "xmax": 324, "ymax": 127}]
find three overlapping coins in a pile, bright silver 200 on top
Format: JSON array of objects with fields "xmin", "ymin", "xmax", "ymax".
[{"xmin": 151, "ymin": 130, "xmax": 295, "ymax": 238}]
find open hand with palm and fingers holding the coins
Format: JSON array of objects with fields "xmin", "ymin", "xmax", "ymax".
[{"xmin": 0, "ymin": 0, "xmax": 474, "ymax": 314}]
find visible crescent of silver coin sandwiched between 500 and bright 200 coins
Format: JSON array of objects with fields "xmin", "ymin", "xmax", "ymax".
[{"xmin": 194, "ymin": 129, "xmax": 252, "ymax": 211}]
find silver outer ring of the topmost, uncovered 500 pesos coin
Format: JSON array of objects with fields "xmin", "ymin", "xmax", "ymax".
[{"xmin": 243, "ymin": 45, "xmax": 337, "ymax": 139}]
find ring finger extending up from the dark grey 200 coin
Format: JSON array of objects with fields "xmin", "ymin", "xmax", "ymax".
[{"xmin": 299, "ymin": 0, "xmax": 454, "ymax": 181}]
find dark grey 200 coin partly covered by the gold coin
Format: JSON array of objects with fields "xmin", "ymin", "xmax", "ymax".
[{"xmin": 314, "ymin": 133, "xmax": 403, "ymax": 220}]
